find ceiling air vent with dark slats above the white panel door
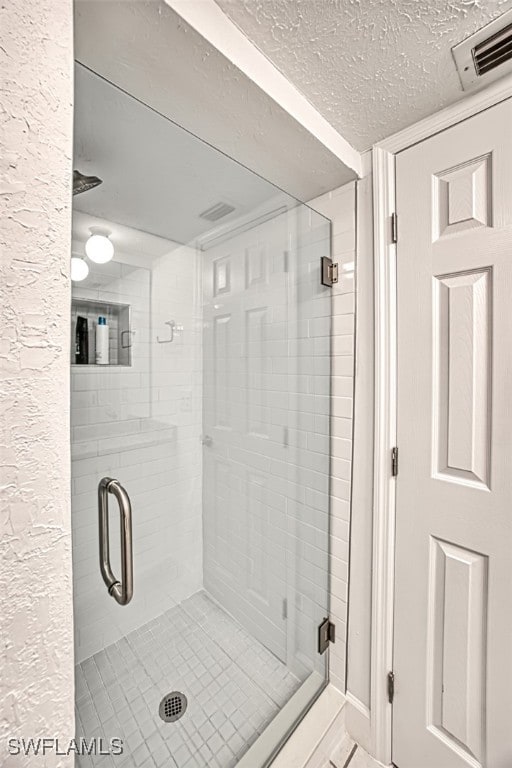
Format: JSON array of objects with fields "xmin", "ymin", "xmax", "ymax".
[{"xmin": 452, "ymin": 10, "xmax": 512, "ymax": 91}]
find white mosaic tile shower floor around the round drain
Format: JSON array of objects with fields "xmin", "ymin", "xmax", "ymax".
[{"xmin": 76, "ymin": 592, "xmax": 300, "ymax": 768}]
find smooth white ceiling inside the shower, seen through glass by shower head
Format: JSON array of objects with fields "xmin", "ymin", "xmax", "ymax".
[{"xmin": 73, "ymin": 65, "xmax": 285, "ymax": 243}]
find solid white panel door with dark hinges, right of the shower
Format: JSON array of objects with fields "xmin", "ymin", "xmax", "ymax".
[{"xmin": 393, "ymin": 100, "xmax": 512, "ymax": 768}]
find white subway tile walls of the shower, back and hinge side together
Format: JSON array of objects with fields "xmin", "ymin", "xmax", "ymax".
[{"xmin": 72, "ymin": 184, "xmax": 356, "ymax": 691}]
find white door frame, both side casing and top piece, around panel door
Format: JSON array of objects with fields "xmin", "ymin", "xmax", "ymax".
[{"xmin": 370, "ymin": 76, "xmax": 512, "ymax": 768}]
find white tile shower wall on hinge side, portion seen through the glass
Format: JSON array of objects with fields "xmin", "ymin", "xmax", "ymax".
[{"xmin": 204, "ymin": 202, "xmax": 338, "ymax": 675}]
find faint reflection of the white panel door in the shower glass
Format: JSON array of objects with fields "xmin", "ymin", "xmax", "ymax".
[{"xmin": 203, "ymin": 216, "xmax": 288, "ymax": 661}]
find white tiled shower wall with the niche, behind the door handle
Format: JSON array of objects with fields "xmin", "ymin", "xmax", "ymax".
[{"xmin": 71, "ymin": 236, "xmax": 202, "ymax": 661}]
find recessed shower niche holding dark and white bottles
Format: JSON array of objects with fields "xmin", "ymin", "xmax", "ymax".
[{"xmin": 71, "ymin": 296, "xmax": 134, "ymax": 368}]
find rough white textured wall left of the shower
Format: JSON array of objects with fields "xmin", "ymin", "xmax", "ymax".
[{"xmin": 0, "ymin": 0, "xmax": 74, "ymax": 768}]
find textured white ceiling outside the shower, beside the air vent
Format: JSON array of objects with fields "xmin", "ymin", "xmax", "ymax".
[{"xmin": 216, "ymin": 0, "xmax": 512, "ymax": 150}]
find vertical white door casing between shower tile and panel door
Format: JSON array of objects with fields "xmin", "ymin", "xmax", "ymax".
[{"xmin": 370, "ymin": 142, "xmax": 396, "ymax": 764}]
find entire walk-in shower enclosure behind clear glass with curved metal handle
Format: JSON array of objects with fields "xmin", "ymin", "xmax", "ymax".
[{"xmin": 71, "ymin": 64, "xmax": 331, "ymax": 768}]
